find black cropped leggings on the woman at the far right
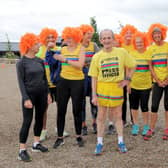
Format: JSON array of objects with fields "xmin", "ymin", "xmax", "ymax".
[{"xmin": 151, "ymin": 83, "xmax": 168, "ymax": 113}]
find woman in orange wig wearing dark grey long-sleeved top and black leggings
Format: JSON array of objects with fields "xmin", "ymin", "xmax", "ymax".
[{"xmin": 16, "ymin": 33, "xmax": 51, "ymax": 162}]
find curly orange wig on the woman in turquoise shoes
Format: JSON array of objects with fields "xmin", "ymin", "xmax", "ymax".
[{"xmin": 132, "ymin": 32, "xmax": 149, "ymax": 49}]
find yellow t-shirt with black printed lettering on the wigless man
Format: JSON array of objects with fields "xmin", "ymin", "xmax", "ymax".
[{"xmin": 89, "ymin": 47, "xmax": 136, "ymax": 82}]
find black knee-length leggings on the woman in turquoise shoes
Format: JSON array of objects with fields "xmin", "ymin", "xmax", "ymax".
[{"xmin": 129, "ymin": 88, "xmax": 151, "ymax": 112}]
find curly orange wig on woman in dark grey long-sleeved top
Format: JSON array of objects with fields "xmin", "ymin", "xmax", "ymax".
[{"xmin": 19, "ymin": 33, "xmax": 40, "ymax": 55}]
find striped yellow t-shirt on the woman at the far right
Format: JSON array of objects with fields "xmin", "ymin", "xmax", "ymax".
[{"xmin": 147, "ymin": 42, "xmax": 168, "ymax": 81}]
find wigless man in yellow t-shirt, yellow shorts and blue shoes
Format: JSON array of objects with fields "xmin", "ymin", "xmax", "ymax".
[{"xmin": 89, "ymin": 29, "xmax": 135, "ymax": 155}]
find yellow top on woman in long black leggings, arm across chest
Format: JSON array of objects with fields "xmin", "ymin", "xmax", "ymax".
[{"xmin": 60, "ymin": 44, "xmax": 84, "ymax": 80}]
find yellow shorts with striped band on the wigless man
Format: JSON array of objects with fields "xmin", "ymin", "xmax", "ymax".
[{"xmin": 97, "ymin": 82, "xmax": 123, "ymax": 107}]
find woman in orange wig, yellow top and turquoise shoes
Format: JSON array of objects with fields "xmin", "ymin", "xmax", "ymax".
[{"xmin": 128, "ymin": 32, "xmax": 152, "ymax": 136}]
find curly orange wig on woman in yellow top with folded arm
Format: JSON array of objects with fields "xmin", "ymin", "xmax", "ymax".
[{"xmin": 62, "ymin": 27, "xmax": 83, "ymax": 43}]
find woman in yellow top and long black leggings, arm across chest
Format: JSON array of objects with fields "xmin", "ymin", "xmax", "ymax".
[{"xmin": 53, "ymin": 27, "xmax": 85, "ymax": 148}]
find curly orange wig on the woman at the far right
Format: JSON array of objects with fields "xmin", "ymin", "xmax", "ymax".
[{"xmin": 148, "ymin": 23, "xmax": 167, "ymax": 42}]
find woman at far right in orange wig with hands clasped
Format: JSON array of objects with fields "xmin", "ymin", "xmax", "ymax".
[{"xmin": 144, "ymin": 23, "xmax": 168, "ymax": 140}]
